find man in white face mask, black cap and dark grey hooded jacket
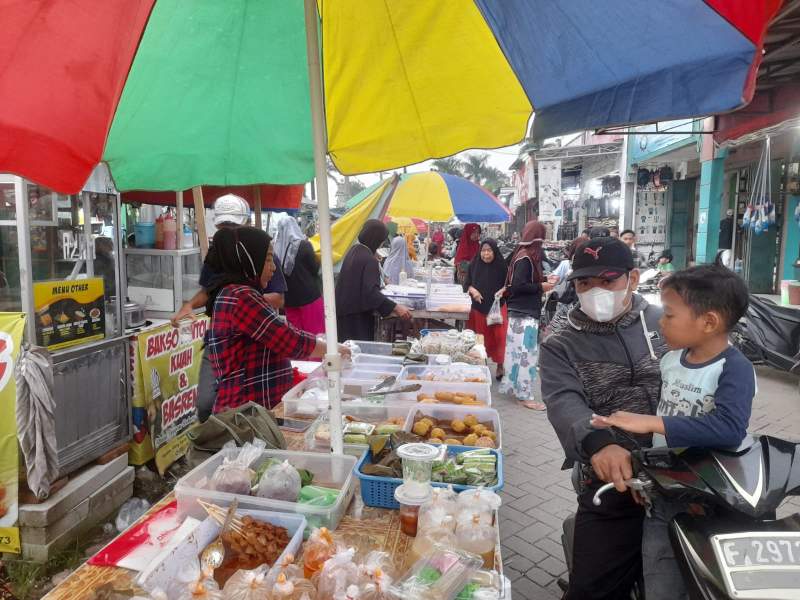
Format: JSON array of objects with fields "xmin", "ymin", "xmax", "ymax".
[{"xmin": 539, "ymin": 237, "xmax": 666, "ymax": 600}]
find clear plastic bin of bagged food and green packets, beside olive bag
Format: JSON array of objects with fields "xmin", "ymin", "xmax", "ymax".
[{"xmin": 180, "ymin": 449, "xmax": 357, "ymax": 530}]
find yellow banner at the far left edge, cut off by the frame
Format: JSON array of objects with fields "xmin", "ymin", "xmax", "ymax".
[{"xmin": 0, "ymin": 313, "xmax": 25, "ymax": 554}]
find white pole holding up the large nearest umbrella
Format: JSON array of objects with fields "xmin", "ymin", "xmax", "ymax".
[{"xmin": 304, "ymin": 0, "xmax": 344, "ymax": 454}]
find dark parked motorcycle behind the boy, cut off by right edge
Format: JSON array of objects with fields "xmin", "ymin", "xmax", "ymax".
[{"xmin": 731, "ymin": 294, "xmax": 800, "ymax": 373}]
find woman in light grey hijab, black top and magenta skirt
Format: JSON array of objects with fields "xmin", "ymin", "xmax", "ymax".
[{"xmin": 275, "ymin": 216, "xmax": 325, "ymax": 334}]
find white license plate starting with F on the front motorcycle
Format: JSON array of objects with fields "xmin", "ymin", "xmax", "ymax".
[{"xmin": 711, "ymin": 531, "xmax": 800, "ymax": 600}]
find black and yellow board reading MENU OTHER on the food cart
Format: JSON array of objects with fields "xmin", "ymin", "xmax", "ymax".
[{"xmin": 33, "ymin": 277, "xmax": 106, "ymax": 350}]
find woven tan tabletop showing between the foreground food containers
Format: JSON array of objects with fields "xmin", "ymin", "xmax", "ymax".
[{"xmin": 44, "ymin": 405, "xmax": 502, "ymax": 600}]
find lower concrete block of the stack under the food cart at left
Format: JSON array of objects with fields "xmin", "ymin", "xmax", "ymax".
[{"xmin": 21, "ymin": 467, "xmax": 134, "ymax": 562}]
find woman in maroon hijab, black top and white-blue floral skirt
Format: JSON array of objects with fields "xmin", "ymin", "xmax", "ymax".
[{"xmin": 500, "ymin": 221, "xmax": 553, "ymax": 410}]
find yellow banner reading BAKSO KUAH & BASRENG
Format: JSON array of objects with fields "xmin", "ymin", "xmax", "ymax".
[{"xmin": 130, "ymin": 317, "xmax": 209, "ymax": 475}]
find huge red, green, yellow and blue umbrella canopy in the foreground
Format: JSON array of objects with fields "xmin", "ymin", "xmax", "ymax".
[{"xmin": 0, "ymin": 0, "xmax": 780, "ymax": 193}]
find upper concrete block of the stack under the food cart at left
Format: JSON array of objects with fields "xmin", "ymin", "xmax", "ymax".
[{"xmin": 19, "ymin": 455, "xmax": 128, "ymax": 527}]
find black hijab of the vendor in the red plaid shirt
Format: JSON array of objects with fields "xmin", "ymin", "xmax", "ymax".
[{"xmin": 205, "ymin": 227, "xmax": 272, "ymax": 316}]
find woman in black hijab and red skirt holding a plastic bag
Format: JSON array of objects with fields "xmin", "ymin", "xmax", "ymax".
[{"xmin": 464, "ymin": 239, "xmax": 508, "ymax": 380}]
